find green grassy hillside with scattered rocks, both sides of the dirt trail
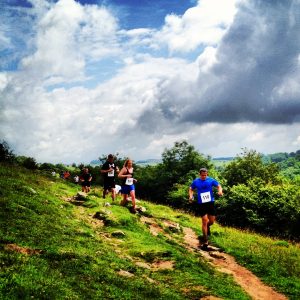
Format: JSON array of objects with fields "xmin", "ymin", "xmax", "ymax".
[{"xmin": 0, "ymin": 165, "xmax": 300, "ymax": 299}]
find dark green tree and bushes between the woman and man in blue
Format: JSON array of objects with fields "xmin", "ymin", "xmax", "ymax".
[{"xmin": 136, "ymin": 141, "xmax": 213, "ymax": 207}]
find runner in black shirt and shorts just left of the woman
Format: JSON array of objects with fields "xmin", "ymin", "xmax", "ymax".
[{"xmin": 101, "ymin": 154, "xmax": 119, "ymax": 201}]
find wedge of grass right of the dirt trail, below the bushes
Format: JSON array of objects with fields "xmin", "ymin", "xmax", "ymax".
[{"xmin": 213, "ymin": 226, "xmax": 300, "ymax": 299}]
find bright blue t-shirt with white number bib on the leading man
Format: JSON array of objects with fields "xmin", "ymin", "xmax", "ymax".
[{"xmin": 191, "ymin": 177, "xmax": 219, "ymax": 204}]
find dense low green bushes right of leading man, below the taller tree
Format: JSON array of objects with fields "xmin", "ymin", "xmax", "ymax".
[{"xmin": 217, "ymin": 178, "xmax": 300, "ymax": 240}]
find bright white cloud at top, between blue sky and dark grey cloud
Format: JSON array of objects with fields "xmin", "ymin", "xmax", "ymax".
[{"xmin": 155, "ymin": 0, "xmax": 237, "ymax": 52}]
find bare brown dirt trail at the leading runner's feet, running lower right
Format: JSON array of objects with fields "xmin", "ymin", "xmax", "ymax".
[{"xmin": 183, "ymin": 228, "xmax": 287, "ymax": 300}]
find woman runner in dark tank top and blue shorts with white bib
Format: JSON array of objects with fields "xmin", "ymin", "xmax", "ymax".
[{"xmin": 118, "ymin": 159, "xmax": 137, "ymax": 214}]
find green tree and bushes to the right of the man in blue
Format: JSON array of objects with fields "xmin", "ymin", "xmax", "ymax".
[{"xmin": 217, "ymin": 150, "xmax": 300, "ymax": 240}]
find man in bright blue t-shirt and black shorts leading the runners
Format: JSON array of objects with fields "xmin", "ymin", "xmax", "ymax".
[{"xmin": 189, "ymin": 168, "xmax": 223, "ymax": 250}]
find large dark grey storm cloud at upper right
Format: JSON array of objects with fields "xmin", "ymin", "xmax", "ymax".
[{"xmin": 135, "ymin": 1, "xmax": 300, "ymax": 132}]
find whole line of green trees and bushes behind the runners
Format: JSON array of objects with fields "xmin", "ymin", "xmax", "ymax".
[{"xmin": 0, "ymin": 141, "xmax": 300, "ymax": 241}]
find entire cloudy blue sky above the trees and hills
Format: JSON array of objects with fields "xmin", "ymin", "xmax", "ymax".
[{"xmin": 0, "ymin": 0, "xmax": 300, "ymax": 163}]
